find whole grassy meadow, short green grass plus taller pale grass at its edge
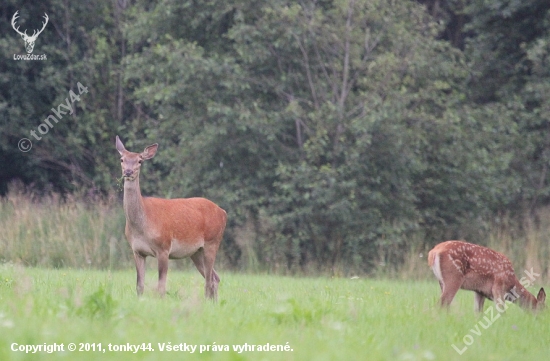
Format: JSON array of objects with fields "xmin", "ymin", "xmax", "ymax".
[{"xmin": 0, "ymin": 192, "xmax": 550, "ymax": 361}]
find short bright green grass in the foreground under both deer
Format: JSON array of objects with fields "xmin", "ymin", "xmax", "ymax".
[{"xmin": 0, "ymin": 260, "xmax": 550, "ymax": 360}]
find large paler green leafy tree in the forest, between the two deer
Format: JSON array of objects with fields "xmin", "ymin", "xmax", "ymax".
[{"xmin": 221, "ymin": 1, "xmax": 510, "ymax": 268}]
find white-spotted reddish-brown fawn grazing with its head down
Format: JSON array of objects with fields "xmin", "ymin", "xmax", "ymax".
[{"xmin": 428, "ymin": 241, "xmax": 546, "ymax": 312}]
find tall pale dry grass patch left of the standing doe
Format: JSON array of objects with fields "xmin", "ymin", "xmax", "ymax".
[{"xmin": 0, "ymin": 190, "xmax": 129, "ymax": 268}]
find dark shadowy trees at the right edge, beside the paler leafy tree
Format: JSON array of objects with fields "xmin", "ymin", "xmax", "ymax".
[{"xmin": 465, "ymin": 0, "xmax": 550, "ymax": 212}]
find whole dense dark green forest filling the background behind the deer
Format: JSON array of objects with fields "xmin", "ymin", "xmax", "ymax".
[{"xmin": 0, "ymin": 0, "xmax": 550, "ymax": 269}]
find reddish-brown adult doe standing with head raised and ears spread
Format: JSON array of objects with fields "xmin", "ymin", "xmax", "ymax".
[{"xmin": 116, "ymin": 135, "xmax": 227, "ymax": 300}]
